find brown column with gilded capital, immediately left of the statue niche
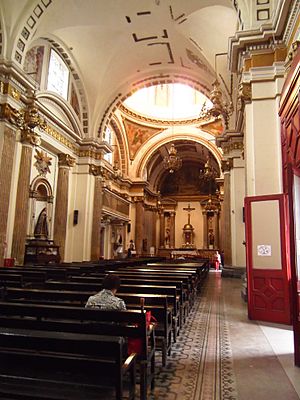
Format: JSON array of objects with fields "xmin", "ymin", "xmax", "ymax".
[{"xmin": 11, "ymin": 130, "xmax": 40, "ymax": 265}]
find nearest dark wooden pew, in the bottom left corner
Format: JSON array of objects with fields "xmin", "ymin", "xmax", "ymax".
[{"xmin": 0, "ymin": 328, "xmax": 136, "ymax": 400}]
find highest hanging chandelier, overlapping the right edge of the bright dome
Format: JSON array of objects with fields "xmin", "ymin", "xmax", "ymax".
[{"xmin": 199, "ymin": 53, "xmax": 234, "ymax": 129}]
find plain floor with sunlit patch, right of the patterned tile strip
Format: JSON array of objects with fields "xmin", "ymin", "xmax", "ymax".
[{"xmin": 221, "ymin": 273, "xmax": 300, "ymax": 400}]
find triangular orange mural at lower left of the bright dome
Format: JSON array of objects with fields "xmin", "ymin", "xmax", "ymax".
[{"xmin": 123, "ymin": 119, "xmax": 161, "ymax": 160}]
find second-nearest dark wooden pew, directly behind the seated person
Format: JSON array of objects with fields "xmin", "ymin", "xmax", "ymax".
[{"xmin": 0, "ymin": 302, "xmax": 155, "ymax": 399}]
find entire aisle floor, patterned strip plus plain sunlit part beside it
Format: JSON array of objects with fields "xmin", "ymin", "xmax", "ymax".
[{"xmin": 150, "ymin": 272, "xmax": 300, "ymax": 400}]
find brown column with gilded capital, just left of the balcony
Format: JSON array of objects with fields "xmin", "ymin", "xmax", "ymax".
[{"xmin": 90, "ymin": 165, "xmax": 105, "ymax": 261}]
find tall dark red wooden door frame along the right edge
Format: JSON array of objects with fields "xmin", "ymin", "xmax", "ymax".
[{"xmin": 279, "ymin": 46, "xmax": 300, "ymax": 367}]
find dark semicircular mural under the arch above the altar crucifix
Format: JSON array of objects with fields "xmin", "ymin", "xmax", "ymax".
[{"xmin": 160, "ymin": 163, "xmax": 217, "ymax": 196}]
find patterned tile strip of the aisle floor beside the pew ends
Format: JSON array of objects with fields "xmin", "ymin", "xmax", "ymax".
[{"xmin": 150, "ymin": 270, "xmax": 237, "ymax": 400}]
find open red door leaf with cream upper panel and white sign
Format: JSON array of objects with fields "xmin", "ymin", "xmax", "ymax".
[{"xmin": 245, "ymin": 194, "xmax": 291, "ymax": 324}]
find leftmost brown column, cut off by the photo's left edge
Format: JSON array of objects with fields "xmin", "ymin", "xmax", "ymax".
[{"xmin": 0, "ymin": 125, "xmax": 15, "ymax": 265}]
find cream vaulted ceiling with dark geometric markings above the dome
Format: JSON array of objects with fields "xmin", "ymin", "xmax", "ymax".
[{"xmin": 0, "ymin": 0, "xmax": 237, "ymax": 124}]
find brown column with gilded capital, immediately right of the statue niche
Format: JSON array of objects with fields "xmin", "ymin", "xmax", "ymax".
[{"xmin": 53, "ymin": 153, "xmax": 75, "ymax": 261}]
